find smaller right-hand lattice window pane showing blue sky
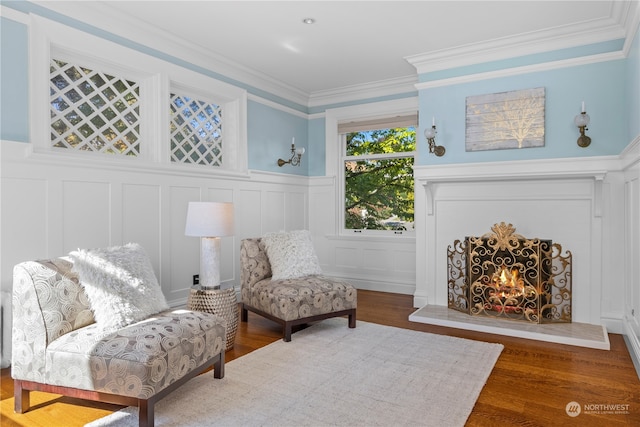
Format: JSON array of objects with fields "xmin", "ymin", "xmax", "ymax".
[{"xmin": 169, "ymin": 94, "xmax": 222, "ymax": 166}]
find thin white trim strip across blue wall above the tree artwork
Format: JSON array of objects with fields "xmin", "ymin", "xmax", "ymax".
[{"xmin": 416, "ymin": 52, "xmax": 625, "ymax": 90}]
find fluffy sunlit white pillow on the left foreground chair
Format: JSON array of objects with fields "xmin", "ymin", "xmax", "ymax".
[{"xmin": 69, "ymin": 243, "xmax": 169, "ymax": 329}]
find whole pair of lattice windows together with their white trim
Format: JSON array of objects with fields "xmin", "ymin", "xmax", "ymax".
[{"xmin": 29, "ymin": 16, "xmax": 247, "ymax": 173}]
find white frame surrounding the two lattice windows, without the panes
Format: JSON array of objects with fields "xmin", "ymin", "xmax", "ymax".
[{"xmin": 29, "ymin": 15, "xmax": 248, "ymax": 174}]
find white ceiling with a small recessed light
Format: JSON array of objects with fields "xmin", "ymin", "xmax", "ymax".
[{"xmin": 33, "ymin": 0, "xmax": 630, "ymax": 105}]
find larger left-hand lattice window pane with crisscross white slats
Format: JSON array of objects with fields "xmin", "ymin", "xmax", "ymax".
[{"xmin": 49, "ymin": 59, "xmax": 140, "ymax": 156}]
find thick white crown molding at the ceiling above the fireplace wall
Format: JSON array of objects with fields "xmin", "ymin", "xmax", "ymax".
[{"xmin": 405, "ymin": 2, "xmax": 628, "ymax": 74}]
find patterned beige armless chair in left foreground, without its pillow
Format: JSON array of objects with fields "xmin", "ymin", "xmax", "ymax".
[{"xmin": 11, "ymin": 244, "xmax": 226, "ymax": 426}]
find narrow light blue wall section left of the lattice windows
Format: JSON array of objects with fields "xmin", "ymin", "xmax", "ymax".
[{"xmin": 0, "ymin": 18, "xmax": 29, "ymax": 142}]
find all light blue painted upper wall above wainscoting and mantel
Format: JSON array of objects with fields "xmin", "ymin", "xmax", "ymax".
[{"xmin": 0, "ymin": 2, "xmax": 640, "ymax": 176}]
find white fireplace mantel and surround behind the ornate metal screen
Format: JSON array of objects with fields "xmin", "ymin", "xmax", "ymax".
[{"xmin": 414, "ymin": 156, "xmax": 624, "ymax": 329}]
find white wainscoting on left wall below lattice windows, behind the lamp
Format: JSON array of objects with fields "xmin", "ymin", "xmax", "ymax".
[{"xmin": 0, "ymin": 141, "xmax": 309, "ymax": 372}]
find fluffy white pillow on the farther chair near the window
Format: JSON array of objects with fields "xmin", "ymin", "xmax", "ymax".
[{"xmin": 262, "ymin": 230, "xmax": 322, "ymax": 280}]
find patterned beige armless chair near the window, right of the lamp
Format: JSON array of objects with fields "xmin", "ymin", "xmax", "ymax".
[{"xmin": 240, "ymin": 232, "xmax": 357, "ymax": 341}]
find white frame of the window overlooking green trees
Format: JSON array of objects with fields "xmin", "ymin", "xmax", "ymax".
[{"xmin": 325, "ymin": 97, "xmax": 419, "ymax": 238}]
